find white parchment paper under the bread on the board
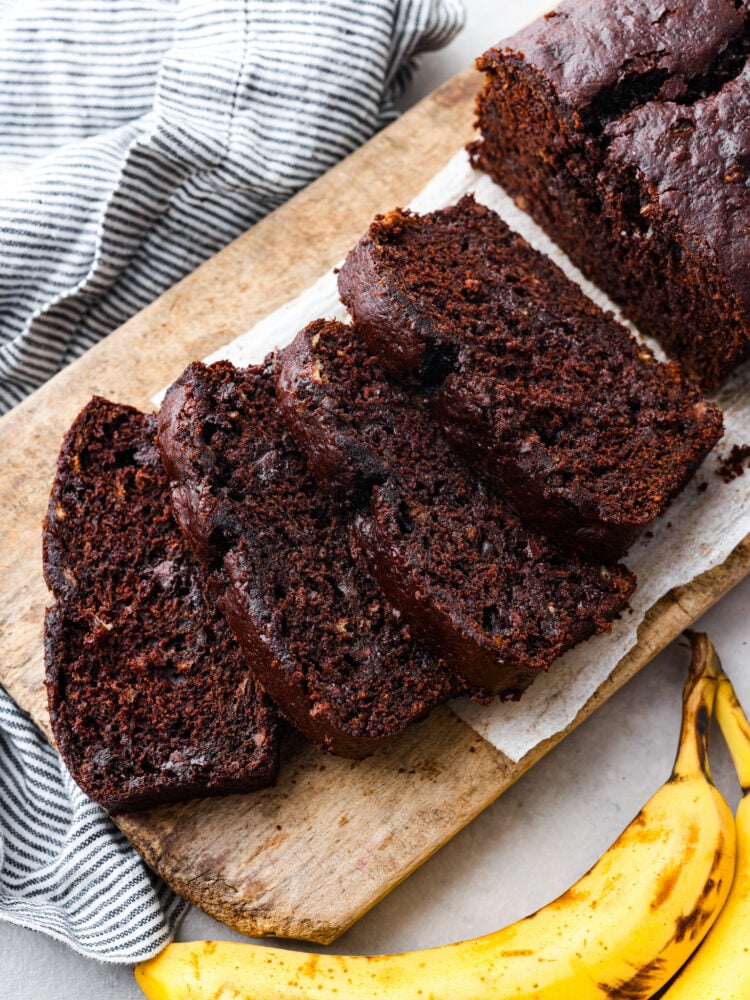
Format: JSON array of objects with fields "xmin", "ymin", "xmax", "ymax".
[{"xmin": 162, "ymin": 150, "xmax": 750, "ymax": 760}]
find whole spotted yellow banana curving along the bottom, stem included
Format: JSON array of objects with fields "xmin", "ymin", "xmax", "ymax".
[{"xmin": 136, "ymin": 641, "xmax": 735, "ymax": 1000}]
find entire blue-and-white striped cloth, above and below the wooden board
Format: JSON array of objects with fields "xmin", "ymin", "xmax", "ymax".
[{"xmin": 0, "ymin": 0, "xmax": 463, "ymax": 960}]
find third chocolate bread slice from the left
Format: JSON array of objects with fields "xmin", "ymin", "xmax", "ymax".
[{"xmin": 277, "ymin": 320, "xmax": 635, "ymax": 697}]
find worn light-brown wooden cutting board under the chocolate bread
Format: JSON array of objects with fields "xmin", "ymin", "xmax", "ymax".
[{"xmin": 0, "ymin": 70, "xmax": 750, "ymax": 943}]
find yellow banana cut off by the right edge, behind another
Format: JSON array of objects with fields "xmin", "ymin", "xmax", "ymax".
[{"xmin": 664, "ymin": 636, "xmax": 750, "ymax": 1000}]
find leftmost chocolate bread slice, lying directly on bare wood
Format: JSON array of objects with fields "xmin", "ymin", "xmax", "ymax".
[{"xmin": 44, "ymin": 398, "xmax": 278, "ymax": 812}]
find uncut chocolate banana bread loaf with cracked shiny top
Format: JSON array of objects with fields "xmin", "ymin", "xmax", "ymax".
[{"xmin": 471, "ymin": 0, "xmax": 750, "ymax": 388}]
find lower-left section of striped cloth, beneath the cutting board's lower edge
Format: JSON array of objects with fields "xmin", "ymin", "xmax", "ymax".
[{"xmin": 0, "ymin": 688, "xmax": 186, "ymax": 960}]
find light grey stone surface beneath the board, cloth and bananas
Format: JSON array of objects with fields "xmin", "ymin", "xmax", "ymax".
[{"xmin": 5, "ymin": 0, "xmax": 750, "ymax": 1000}]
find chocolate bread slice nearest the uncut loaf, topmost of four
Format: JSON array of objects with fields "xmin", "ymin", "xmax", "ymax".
[{"xmin": 339, "ymin": 196, "xmax": 722, "ymax": 560}]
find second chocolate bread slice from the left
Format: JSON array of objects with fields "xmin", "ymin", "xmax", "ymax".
[{"xmin": 159, "ymin": 362, "xmax": 460, "ymax": 757}]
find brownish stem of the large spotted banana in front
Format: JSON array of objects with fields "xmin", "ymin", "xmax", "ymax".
[{"xmin": 672, "ymin": 632, "xmax": 725, "ymax": 780}]
